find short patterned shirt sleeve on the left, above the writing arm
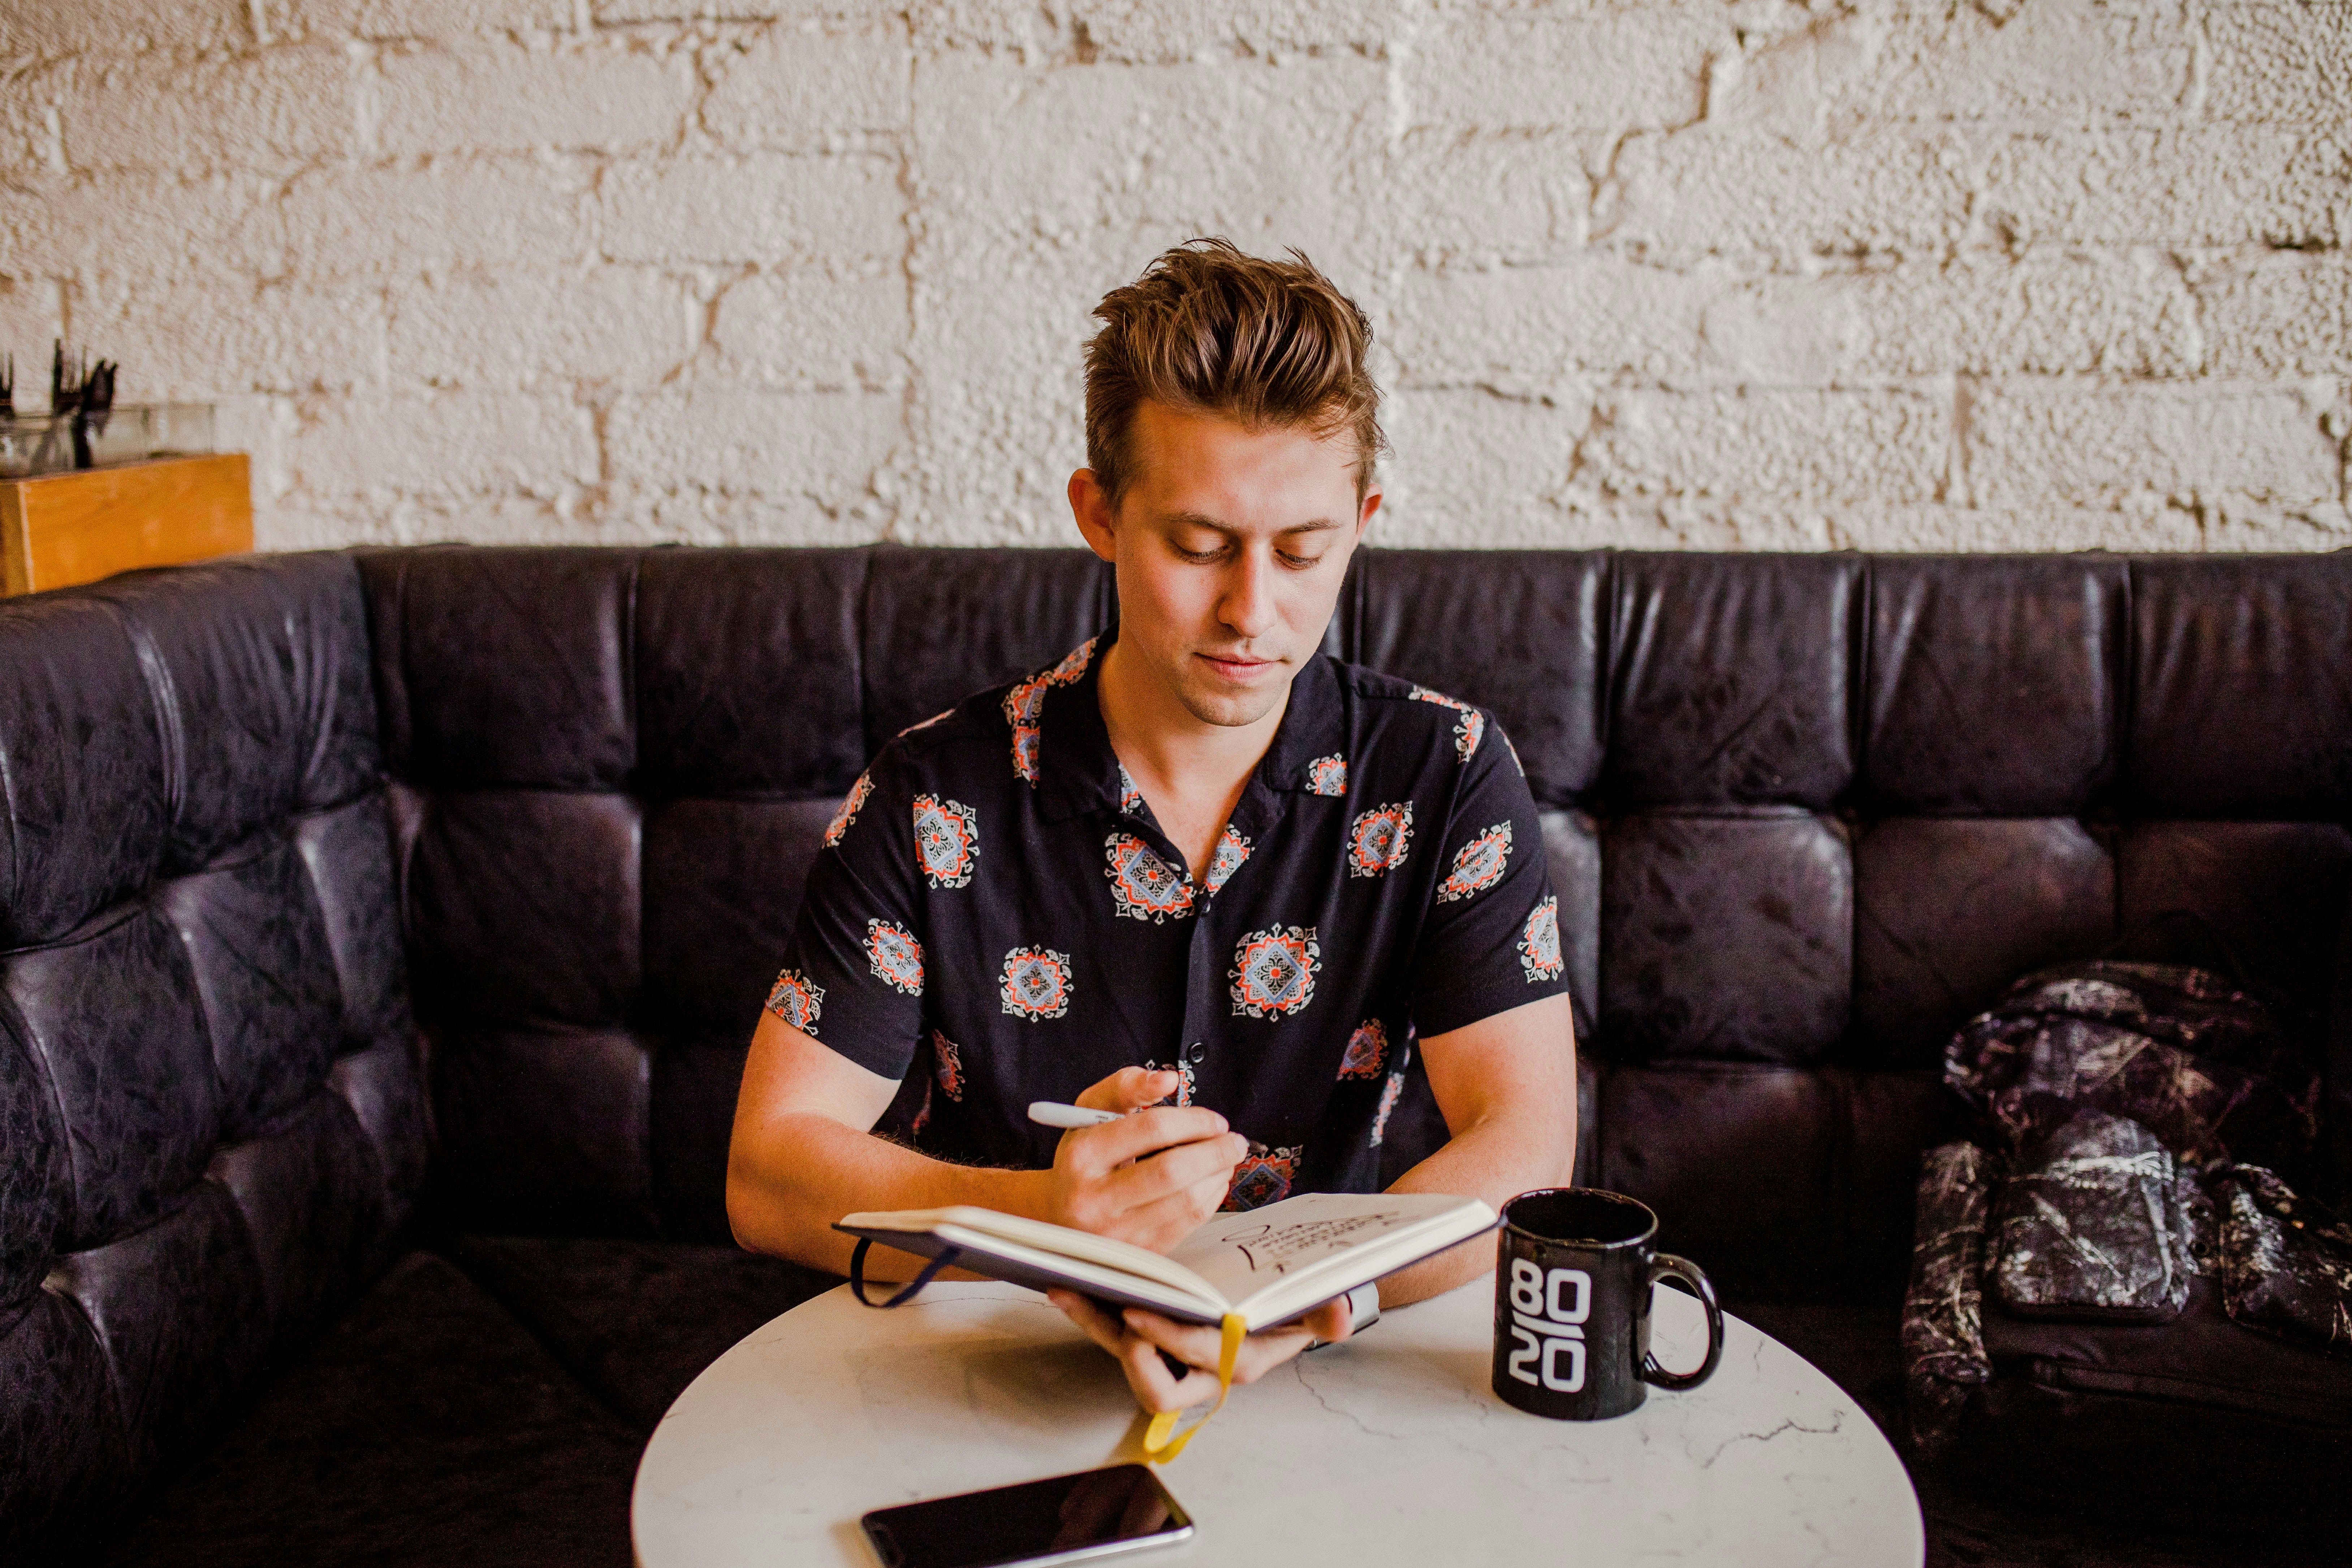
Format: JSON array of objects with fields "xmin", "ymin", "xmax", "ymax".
[{"xmin": 767, "ymin": 745, "xmax": 924, "ymax": 1079}]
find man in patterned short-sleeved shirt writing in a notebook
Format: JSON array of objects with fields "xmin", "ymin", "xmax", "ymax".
[{"xmin": 727, "ymin": 240, "xmax": 1576, "ymax": 1411}]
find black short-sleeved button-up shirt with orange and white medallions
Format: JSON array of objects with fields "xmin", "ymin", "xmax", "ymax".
[{"xmin": 767, "ymin": 632, "xmax": 1566, "ymax": 1208}]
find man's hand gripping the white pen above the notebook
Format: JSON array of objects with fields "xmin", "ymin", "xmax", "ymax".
[{"xmin": 1042, "ymin": 1067, "xmax": 1249, "ymax": 1253}]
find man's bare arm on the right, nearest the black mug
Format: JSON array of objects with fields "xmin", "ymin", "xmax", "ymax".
[{"xmin": 1381, "ymin": 994, "xmax": 1576, "ymax": 1307}]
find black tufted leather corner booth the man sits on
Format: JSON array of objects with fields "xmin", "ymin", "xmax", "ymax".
[{"xmin": 0, "ymin": 548, "xmax": 2352, "ymax": 1563}]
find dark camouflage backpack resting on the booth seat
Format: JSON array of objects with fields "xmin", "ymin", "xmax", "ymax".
[{"xmin": 1903, "ymin": 962, "xmax": 2352, "ymax": 1453}]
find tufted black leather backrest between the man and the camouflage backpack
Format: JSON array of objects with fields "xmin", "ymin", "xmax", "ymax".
[{"xmin": 1343, "ymin": 552, "xmax": 2352, "ymax": 1298}]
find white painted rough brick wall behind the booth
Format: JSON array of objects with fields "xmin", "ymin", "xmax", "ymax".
[{"xmin": 0, "ymin": 0, "xmax": 2352, "ymax": 550}]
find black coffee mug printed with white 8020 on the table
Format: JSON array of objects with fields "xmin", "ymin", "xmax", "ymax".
[{"xmin": 1493, "ymin": 1187, "xmax": 1724, "ymax": 1420}]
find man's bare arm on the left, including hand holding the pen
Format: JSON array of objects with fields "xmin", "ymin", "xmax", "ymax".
[{"xmin": 727, "ymin": 1013, "xmax": 1247, "ymax": 1279}]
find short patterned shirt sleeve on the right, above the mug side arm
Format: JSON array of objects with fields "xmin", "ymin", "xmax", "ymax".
[{"xmin": 1411, "ymin": 715, "xmax": 1569, "ymax": 1037}]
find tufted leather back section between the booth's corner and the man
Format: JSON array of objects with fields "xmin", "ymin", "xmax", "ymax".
[{"xmin": 360, "ymin": 548, "xmax": 1113, "ymax": 1239}]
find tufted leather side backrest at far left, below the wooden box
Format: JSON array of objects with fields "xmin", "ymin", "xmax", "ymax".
[{"xmin": 0, "ymin": 555, "xmax": 426, "ymax": 1542}]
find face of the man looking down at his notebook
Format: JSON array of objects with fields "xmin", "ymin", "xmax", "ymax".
[{"xmin": 1070, "ymin": 402, "xmax": 1381, "ymax": 724}]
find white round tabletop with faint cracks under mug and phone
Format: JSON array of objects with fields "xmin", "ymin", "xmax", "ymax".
[{"xmin": 630, "ymin": 1277, "xmax": 1926, "ymax": 1568}]
